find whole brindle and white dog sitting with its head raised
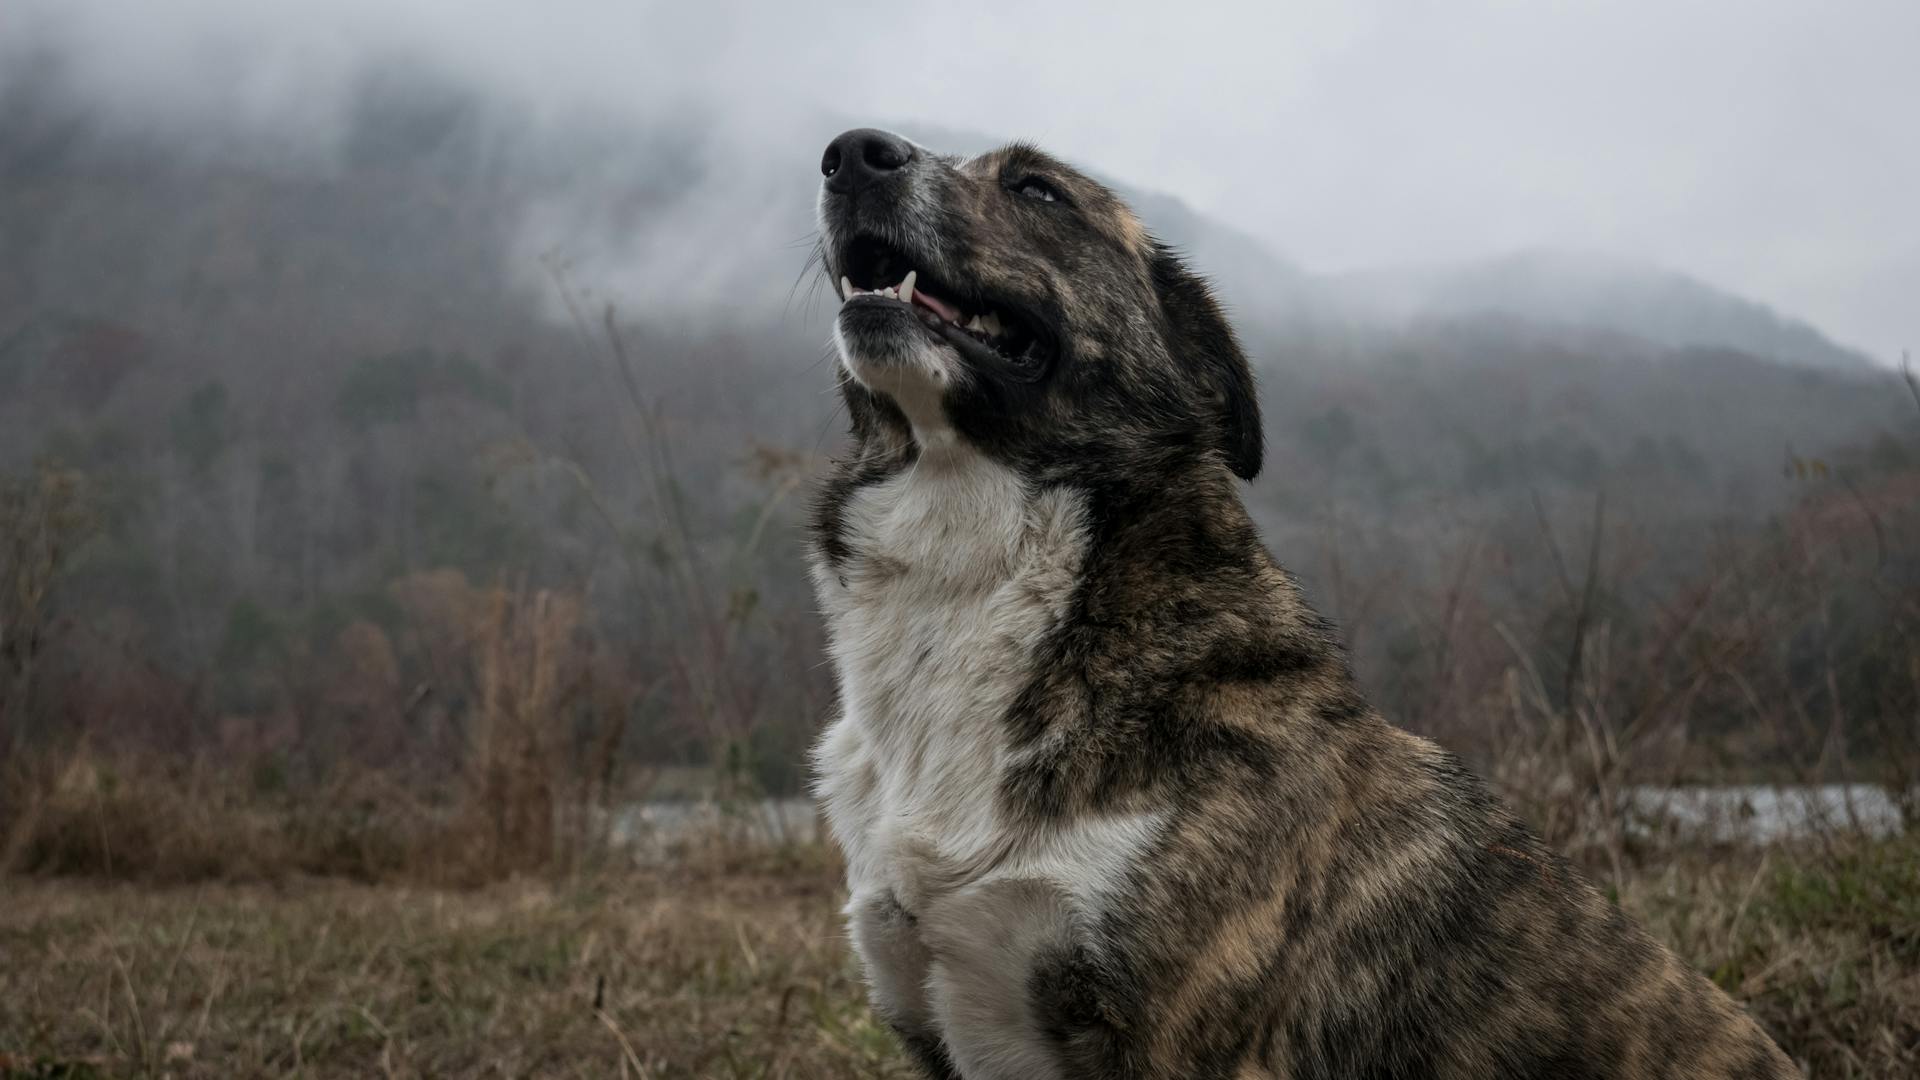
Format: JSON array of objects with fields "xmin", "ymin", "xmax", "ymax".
[{"xmin": 810, "ymin": 129, "xmax": 1799, "ymax": 1080}]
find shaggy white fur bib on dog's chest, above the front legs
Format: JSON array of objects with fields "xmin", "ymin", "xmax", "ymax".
[{"xmin": 816, "ymin": 444, "xmax": 1087, "ymax": 894}]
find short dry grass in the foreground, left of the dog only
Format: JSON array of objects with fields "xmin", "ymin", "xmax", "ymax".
[{"xmin": 0, "ymin": 851, "xmax": 908, "ymax": 1080}]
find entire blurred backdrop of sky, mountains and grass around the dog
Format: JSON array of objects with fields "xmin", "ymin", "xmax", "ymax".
[{"xmin": 0, "ymin": 0, "xmax": 1920, "ymax": 1076}]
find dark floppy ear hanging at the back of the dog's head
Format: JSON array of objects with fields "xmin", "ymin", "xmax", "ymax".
[{"xmin": 1152, "ymin": 244, "xmax": 1265, "ymax": 480}]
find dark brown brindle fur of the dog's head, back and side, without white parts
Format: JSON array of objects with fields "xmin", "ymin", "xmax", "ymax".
[{"xmin": 814, "ymin": 132, "xmax": 1799, "ymax": 1080}]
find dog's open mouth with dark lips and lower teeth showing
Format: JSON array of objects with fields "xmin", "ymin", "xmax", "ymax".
[{"xmin": 839, "ymin": 236, "xmax": 1054, "ymax": 379}]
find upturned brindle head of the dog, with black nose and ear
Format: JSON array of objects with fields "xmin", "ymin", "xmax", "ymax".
[{"xmin": 820, "ymin": 129, "xmax": 1261, "ymax": 482}]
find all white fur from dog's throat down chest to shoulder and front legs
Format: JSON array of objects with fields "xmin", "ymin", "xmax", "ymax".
[{"xmin": 814, "ymin": 350, "xmax": 1164, "ymax": 1078}]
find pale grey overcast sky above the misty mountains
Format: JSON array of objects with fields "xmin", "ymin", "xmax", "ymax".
[{"xmin": 18, "ymin": 0, "xmax": 1920, "ymax": 361}]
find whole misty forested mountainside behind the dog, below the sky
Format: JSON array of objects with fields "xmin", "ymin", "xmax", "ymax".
[{"xmin": 0, "ymin": 65, "xmax": 1920, "ymax": 790}]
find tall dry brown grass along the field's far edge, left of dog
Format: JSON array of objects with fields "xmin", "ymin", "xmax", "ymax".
[{"xmin": 0, "ymin": 575, "xmax": 645, "ymax": 886}]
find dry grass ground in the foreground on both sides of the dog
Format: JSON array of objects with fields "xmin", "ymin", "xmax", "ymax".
[{"xmin": 0, "ymin": 840, "xmax": 1920, "ymax": 1080}]
